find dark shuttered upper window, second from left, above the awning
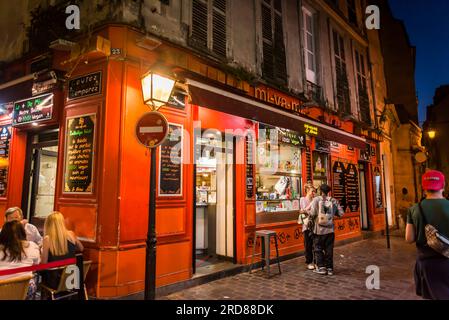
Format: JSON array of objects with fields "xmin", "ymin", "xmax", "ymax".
[{"xmin": 261, "ymin": 0, "xmax": 287, "ymax": 84}]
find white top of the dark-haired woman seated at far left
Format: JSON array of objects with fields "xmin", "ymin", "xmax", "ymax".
[{"xmin": 0, "ymin": 241, "xmax": 41, "ymax": 280}]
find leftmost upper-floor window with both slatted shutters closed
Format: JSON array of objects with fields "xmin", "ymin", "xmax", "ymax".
[{"xmin": 190, "ymin": 0, "xmax": 227, "ymax": 57}]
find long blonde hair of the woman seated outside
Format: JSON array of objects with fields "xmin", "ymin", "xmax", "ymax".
[{"xmin": 44, "ymin": 211, "xmax": 69, "ymax": 256}]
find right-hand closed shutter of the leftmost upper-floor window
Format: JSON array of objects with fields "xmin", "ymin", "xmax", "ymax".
[{"xmin": 212, "ymin": 0, "xmax": 226, "ymax": 57}]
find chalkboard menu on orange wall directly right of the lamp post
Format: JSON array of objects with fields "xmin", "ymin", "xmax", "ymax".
[{"xmin": 159, "ymin": 124, "xmax": 183, "ymax": 196}]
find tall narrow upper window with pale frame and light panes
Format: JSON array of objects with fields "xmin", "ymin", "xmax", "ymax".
[{"xmin": 302, "ymin": 7, "xmax": 317, "ymax": 84}]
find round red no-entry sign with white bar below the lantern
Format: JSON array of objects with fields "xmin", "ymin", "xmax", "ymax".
[{"xmin": 136, "ymin": 111, "xmax": 168, "ymax": 148}]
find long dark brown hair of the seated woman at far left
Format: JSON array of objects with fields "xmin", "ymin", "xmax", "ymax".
[{"xmin": 0, "ymin": 221, "xmax": 26, "ymax": 262}]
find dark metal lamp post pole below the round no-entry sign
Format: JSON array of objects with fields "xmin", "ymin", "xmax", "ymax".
[{"xmin": 145, "ymin": 148, "xmax": 157, "ymax": 300}]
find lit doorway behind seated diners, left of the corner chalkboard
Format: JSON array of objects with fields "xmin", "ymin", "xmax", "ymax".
[{"xmin": 22, "ymin": 129, "xmax": 59, "ymax": 233}]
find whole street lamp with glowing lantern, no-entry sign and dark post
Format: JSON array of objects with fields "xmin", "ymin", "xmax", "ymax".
[{"xmin": 138, "ymin": 71, "xmax": 176, "ymax": 300}]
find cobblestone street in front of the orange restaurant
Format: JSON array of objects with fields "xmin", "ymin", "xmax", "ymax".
[{"xmin": 162, "ymin": 237, "xmax": 420, "ymax": 300}]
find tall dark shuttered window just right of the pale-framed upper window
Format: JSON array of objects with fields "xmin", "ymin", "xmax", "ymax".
[{"xmin": 333, "ymin": 30, "xmax": 351, "ymax": 114}]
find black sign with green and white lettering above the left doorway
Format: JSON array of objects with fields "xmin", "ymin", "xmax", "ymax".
[{"xmin": 12, "ymin": 94, "xmax": 53, "ymax": 126}]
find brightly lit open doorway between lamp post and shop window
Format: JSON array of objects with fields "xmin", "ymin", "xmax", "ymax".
[{"xmin": 193, "ymin": 131, "xmax": 235, "ymax": 276}]
